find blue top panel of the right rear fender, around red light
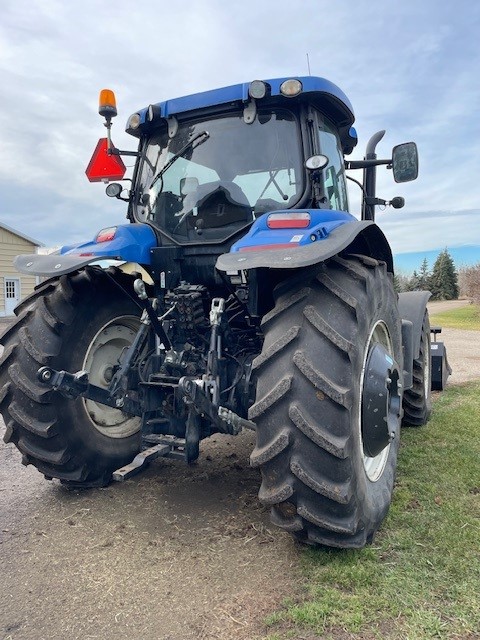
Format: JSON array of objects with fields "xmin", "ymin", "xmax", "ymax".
[{"xmin": 230, "ymin": 209, "xmax": 357, "ymax": 253}]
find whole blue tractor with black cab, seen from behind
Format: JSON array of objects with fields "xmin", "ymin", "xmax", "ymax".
[{"xmin": 0, "ymin": 77, "xmax": 438, "ymax": 548}]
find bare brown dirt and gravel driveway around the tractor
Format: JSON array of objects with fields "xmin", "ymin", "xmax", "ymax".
[{"xmin": 0, "ymin": 302, "xmax": 480, "ymax": 640}]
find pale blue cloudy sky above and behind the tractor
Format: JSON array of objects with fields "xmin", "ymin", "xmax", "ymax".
[{"xmin": 0, "ymin": 0, "xmax": 480, "ymax": 253}]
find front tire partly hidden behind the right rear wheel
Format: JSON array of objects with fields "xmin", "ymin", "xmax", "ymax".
[{"xmin": 403, "ymin": 311, "xmax": 432, "ymax": 427}]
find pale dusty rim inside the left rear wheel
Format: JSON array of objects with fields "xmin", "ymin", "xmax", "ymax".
[{"xmin": 83, "ymin": 316, "xmax": 140, "ymax": 438}]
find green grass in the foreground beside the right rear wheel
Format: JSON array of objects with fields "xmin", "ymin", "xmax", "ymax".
[{"xmin": 268, "ymin": 383, "xmax": 480, "ymax": 640}]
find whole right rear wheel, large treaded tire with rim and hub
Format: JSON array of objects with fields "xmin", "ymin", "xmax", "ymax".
[{"xmin": 249, "ymin": 257, "xmax": 402, "ymax": 548}]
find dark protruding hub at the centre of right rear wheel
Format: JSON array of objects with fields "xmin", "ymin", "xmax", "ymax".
[{"xmin": 362, "ymin": 343, "xmax": 401, "ymax": 458}]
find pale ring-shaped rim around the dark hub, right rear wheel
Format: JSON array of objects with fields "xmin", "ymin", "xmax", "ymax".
[{"xmin": 359, "ymin": 321, "xmax": 400, "ymax": 482}]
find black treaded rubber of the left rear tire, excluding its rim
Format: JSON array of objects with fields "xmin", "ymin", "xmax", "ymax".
[{"xmin": 0, "ymin": 268, "xmax": 139, "ymax": 488}]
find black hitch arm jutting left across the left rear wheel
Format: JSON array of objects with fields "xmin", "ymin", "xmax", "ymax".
[{"xmin": 37, "ymin": 367, "xmax": 142, "ymax": 416}]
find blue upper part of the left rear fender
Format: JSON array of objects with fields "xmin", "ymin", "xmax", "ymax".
[{"xmin": 60, "ymin": 223, "xmax": 158, "ymax": 264}]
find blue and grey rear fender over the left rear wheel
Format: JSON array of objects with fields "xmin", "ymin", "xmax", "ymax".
[{"xmin": 14, "ymin": 223, "xmax": 157, "ymax": 277}]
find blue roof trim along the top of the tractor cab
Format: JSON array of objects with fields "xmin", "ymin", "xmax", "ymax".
[{"xmin": 130, "ymin": 76, "xmax": 355, "ymax": 129}]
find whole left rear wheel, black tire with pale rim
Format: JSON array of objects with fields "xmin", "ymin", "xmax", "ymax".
[{"xmin": 0, "ymin": 268, "xmax": 140, "ymax": 487}]
